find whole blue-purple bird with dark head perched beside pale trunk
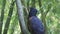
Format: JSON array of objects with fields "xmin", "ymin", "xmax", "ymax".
[{"xmin": 28, "ymin": 7, "xmax": 44, "ymax": 34}]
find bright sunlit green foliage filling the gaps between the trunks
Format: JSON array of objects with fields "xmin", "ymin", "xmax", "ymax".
[{"xmin": 0, "ymin": 0, "xmax": 60, "ymax": 34}]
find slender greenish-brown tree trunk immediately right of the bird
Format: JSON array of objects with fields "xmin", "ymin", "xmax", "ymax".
[{"xmin": 38, "ymin": 0, "xmax": 47, "ymax": 34}]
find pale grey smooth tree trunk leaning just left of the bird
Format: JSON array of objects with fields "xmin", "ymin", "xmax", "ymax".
[{"xmin": 16, "ymin": 0, "xmax": 29, "ymax": 34}]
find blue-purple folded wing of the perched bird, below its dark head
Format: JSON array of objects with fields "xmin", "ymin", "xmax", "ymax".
[{"xmin": 30, "ymin": 17, "xmax": 44, "ymax": 31}]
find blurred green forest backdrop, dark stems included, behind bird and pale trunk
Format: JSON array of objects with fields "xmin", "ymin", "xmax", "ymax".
[{"xmin": 0, "ymin": 0, "xmax": 60, "ymax": 34}]
